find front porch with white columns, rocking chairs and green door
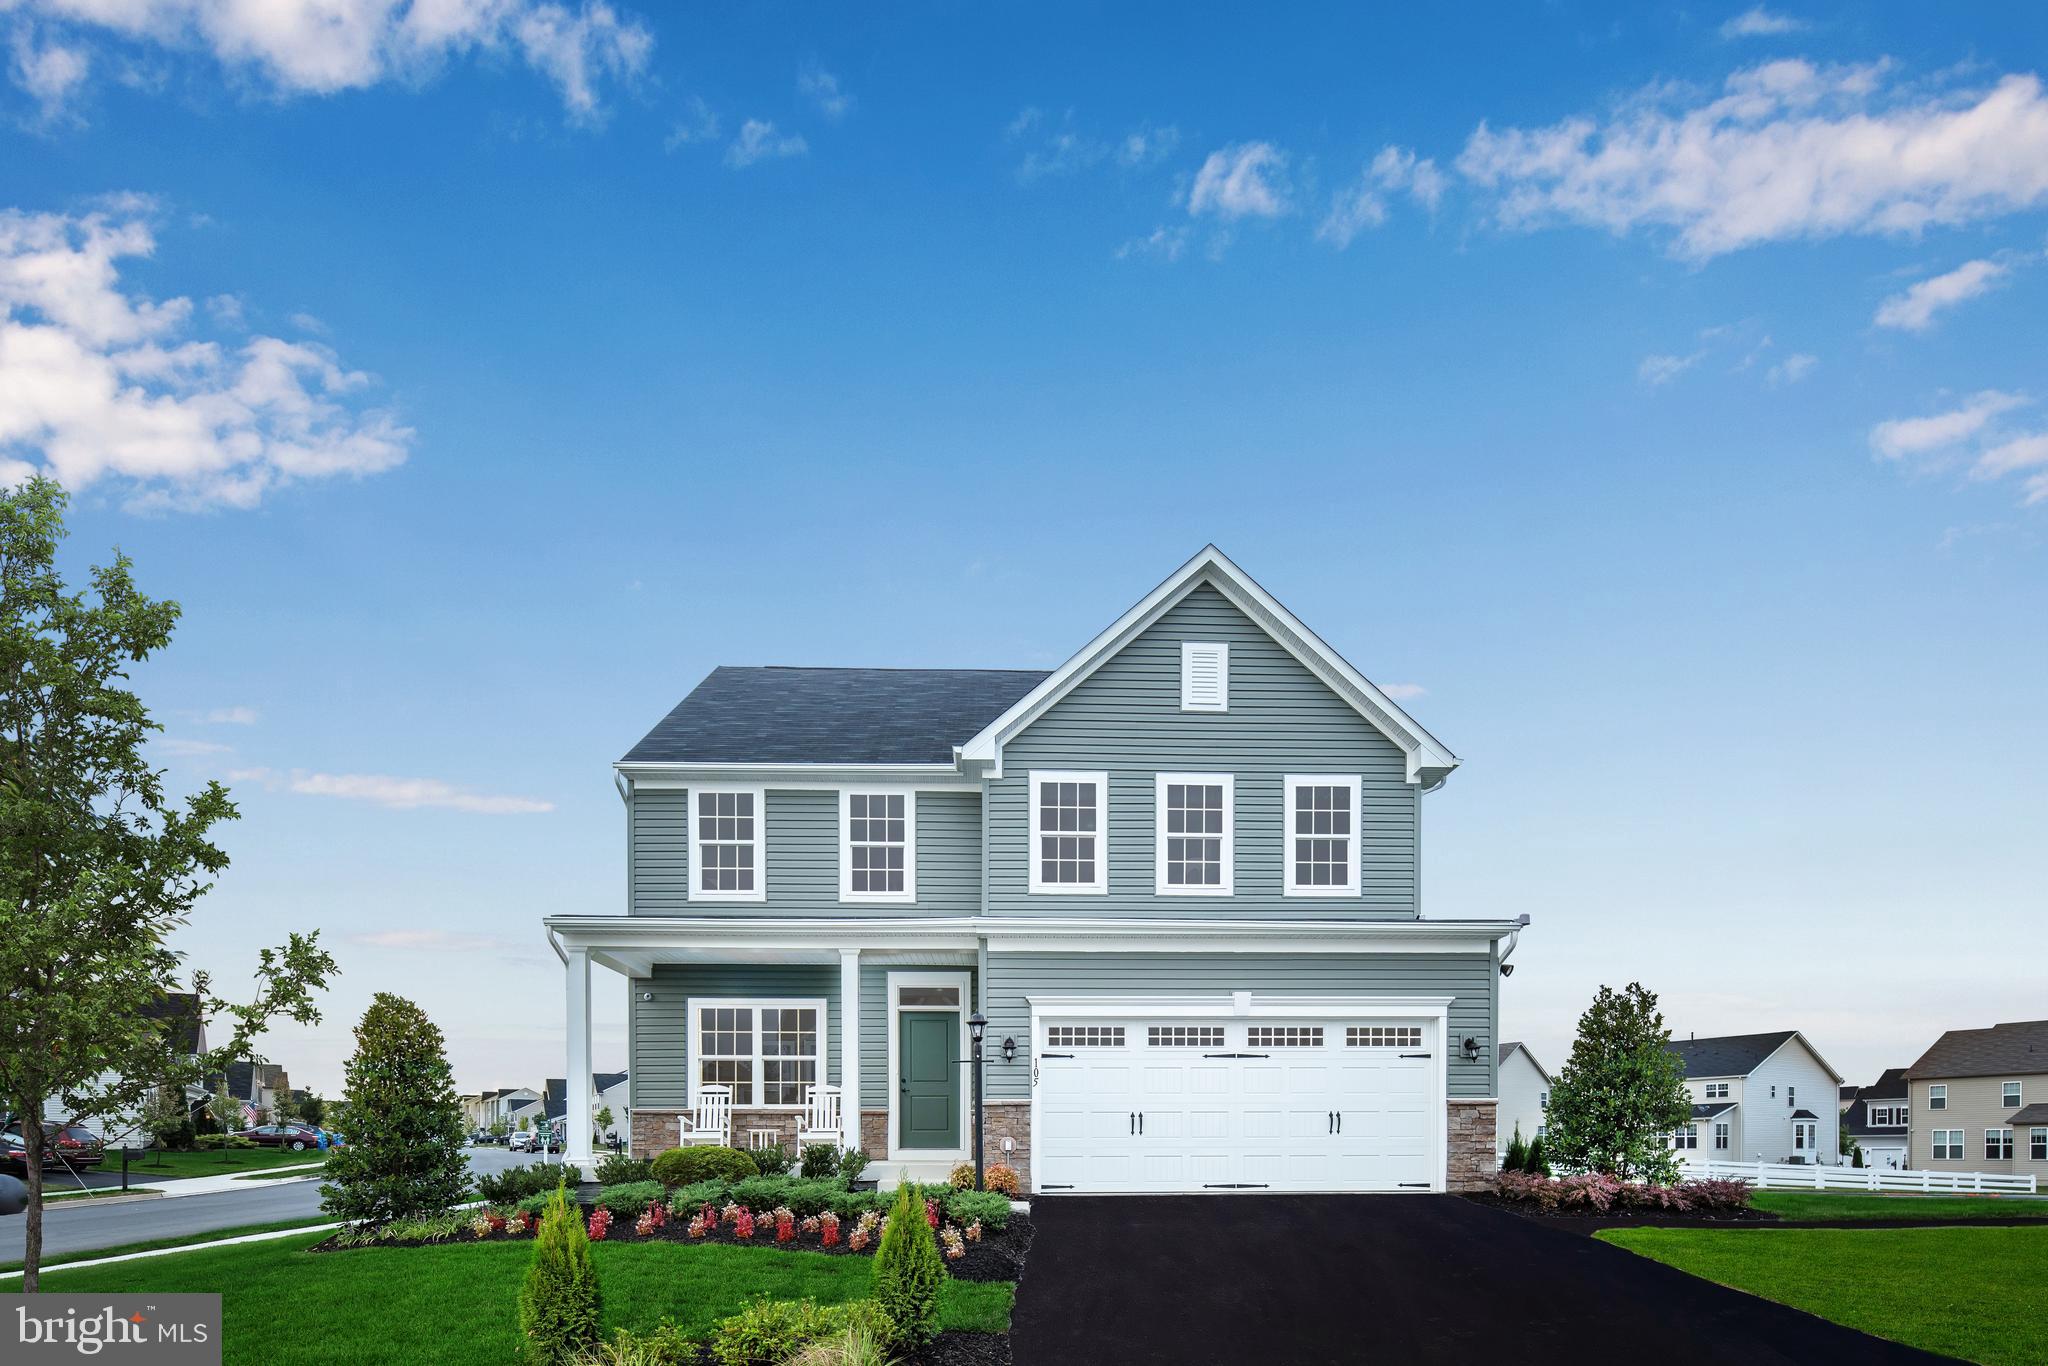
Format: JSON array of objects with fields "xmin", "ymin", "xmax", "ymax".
[{"xmin": 549, "ymin": 917, "xmax": 995, "ymax": 1182}]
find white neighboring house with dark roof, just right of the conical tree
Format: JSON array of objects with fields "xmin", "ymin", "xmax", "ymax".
[{"xmin": 1671, "ymin": 1030, "xmax": 1843, "ymax": 1165}]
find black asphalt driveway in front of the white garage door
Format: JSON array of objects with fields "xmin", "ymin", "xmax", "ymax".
[{"xmin": 1010, "ymin": 1196, "xmax": 1944, "ymax": 1366}]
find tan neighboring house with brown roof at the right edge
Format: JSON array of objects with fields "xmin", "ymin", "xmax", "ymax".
[{"xmin": 1907, "ymin": 1020, "xmax": 2048, "ymax": 1178}]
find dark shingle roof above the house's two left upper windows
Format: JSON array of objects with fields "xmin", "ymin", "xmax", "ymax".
[{"xmin": 621, "ymin": 666, "xmax": 1047, "ymax": 764}]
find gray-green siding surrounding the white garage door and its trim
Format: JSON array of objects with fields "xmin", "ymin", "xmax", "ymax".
[{"xmin": 974, "ymin": 952, "xmax": 1495, "ymax": 1100}]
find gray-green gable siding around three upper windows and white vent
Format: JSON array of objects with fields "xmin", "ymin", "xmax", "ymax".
[{"xmin": 989, "ymin": 584, "xmax": 1421, "ymax": 920}]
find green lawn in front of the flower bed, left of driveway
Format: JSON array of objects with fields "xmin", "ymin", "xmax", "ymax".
[{"xmin": 4, "ymin": 1233, "xmax": 1016, "ymax": 1366}]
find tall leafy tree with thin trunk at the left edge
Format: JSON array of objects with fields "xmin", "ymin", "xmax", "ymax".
[{"xmin": 0, "ymin": 475, "xmax": 334, "ymax": 1292}]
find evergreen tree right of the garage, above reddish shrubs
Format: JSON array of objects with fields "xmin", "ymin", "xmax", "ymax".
[{"xmin": 1544, "ymin": 981, "xmax": 1692, "ymax": 1186}]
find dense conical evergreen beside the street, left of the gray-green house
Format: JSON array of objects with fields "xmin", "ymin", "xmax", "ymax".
[{"xmin": 319, "ymin": 991, "xmax": 469, "ymax": 1223}]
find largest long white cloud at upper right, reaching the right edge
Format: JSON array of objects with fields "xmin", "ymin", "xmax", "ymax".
[{"xmin": 1458, "ymin": 61, "xmax": 2048, "ymax": 260}]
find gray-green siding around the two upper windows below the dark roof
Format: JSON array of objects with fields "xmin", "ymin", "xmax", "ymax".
[{"xmin": 627, "ymin": 788, "xmax": 981, "ymax": 915}]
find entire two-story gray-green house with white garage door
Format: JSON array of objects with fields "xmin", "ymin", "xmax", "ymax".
[{"xmin": 547, "ymin": 547, "xmax": 1528, "ymax": 1192}]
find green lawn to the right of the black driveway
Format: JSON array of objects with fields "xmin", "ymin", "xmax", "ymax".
[{"xmin": 1597, "ymin": 1227, "xmax": 2048, "ymax": 1366}]
